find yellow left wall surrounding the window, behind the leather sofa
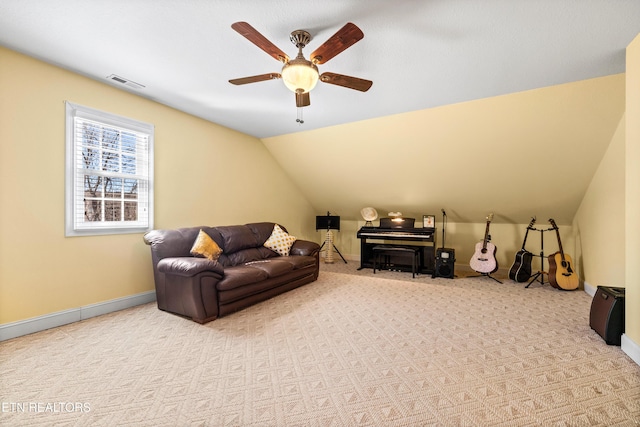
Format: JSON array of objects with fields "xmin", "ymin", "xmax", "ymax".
[{"xmin": 0, "ymin": 47, "xmax": 316, "ymax": 324}]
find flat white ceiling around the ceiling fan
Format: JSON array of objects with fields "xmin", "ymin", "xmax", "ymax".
[{"xmin": 0, "ymin": 0, "xmax": 640, "ymax": 138}]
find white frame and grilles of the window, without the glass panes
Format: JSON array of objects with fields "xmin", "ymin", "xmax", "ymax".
[{"xmin": 65, "ymin": 101, "xmax": 154, "ymax": 236}]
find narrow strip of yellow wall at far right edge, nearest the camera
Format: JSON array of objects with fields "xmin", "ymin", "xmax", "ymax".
[{"xmin": 625, "ymin": 35, "xmax": 640, "ymax": 348}]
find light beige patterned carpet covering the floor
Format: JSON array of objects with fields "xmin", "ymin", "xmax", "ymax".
[{"xmin": 0, "ymin": 264, "xmax": 640, "ymax": 427}]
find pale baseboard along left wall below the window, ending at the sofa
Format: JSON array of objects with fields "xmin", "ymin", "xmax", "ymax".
[{"xmin": 0, "ymin": 291, "xmax": 156, "ymax": 341}]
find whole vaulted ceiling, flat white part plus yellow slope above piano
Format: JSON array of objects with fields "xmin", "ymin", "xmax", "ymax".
[{"xmin": 0, "ymin": 0, "xmax": 640, "ymax": 223}]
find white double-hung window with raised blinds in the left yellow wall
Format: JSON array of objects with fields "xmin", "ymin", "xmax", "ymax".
[{"xmin": 65, "ymin": 102, "xmax": 154, "ymax": 236}]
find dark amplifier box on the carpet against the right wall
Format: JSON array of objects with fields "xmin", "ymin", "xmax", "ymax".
[{"xmin": 589, "ymin": 286, "xmax": 624, "ymax": 345}]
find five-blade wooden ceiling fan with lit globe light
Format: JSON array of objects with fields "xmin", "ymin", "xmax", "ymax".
[{"xmin": 229, "ymin": 22, "xmax": 373, "ymax": 114}]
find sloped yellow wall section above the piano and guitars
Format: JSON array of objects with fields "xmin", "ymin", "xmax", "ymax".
[{"xmin": 263, "ymin": 74, "xmax": 625, "ymax": 232}]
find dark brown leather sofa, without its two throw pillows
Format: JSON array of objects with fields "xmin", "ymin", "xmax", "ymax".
[{"xmin": 144, "ymin": 222, "xmax": 320, "ymax": 323}]
